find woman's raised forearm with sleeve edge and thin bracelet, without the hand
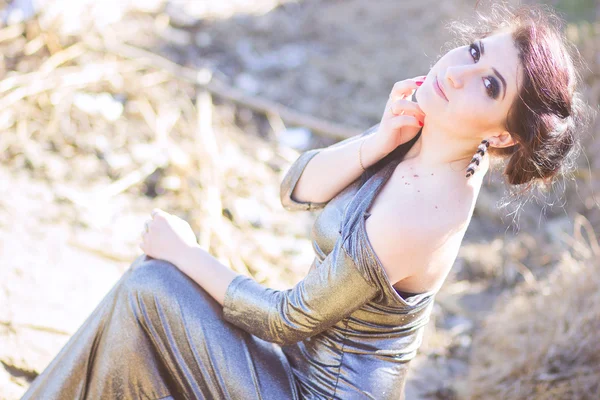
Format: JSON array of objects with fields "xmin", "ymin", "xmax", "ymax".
[{"xmin": 280, "ymin": 124, "xmax": 386, "ymax": 211}]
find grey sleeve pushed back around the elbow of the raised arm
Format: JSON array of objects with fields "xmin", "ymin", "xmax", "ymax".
[{"xmin": 280, "ymin": 124, "xmax": 379, "ymax": 211}]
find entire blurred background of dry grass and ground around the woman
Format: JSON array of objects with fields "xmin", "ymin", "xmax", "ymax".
[{"xmin": 0, "ymin": 0, "xmax": 600, "ymax": 400}]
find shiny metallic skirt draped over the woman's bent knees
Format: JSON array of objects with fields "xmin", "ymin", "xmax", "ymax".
[{"xmin": 22, "ymin": 255, "xmax": 299, "ymax": 400}]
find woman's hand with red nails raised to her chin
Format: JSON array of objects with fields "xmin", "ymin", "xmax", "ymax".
[{"xmin": 372, "ymin": 76, "xmax": 425, "ymax": 154}]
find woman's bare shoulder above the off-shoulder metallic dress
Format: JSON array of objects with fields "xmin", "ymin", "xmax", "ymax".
[{"xmin": 365, "ymin": 180, "xmax": 474, "ymax": 283}]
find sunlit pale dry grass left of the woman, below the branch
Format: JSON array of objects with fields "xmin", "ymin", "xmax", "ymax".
[{"xmin": 0, "ymin": 7, "xmax": 333, "ymax": 287}]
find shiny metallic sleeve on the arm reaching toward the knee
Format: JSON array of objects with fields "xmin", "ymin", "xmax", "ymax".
[{"xmin": 223, "ymin": 222, "xmax": 381, "ymax": 345}]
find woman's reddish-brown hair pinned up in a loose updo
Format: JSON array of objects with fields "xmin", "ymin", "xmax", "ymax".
[{"xmin": 449, "ymin": 2, "xmax": 592, "ymax": 190}]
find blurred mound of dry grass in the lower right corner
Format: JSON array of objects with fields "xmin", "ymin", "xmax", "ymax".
[{"xmin": 464, "ymin": 216, "xmax": 600, "ymax": 400}]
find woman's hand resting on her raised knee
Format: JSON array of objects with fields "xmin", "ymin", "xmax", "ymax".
[{"xmin": 140, "ymin": 208, "xmax": 199, "ymax": 266}]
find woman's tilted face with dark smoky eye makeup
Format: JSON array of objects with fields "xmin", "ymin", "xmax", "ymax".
[{"xmin": 417, "ymin": 31, "xmax": 521, "ymax": 138}]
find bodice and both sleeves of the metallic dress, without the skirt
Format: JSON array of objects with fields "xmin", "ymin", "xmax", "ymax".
[{"xmin": 223, "ymin": 126, "xmax": 435, "ymax": 400}]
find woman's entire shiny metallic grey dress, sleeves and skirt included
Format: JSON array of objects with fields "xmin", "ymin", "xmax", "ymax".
[{"xmin": 23, "ymin": 117, "xmax": 435, "ymax": 400}]
